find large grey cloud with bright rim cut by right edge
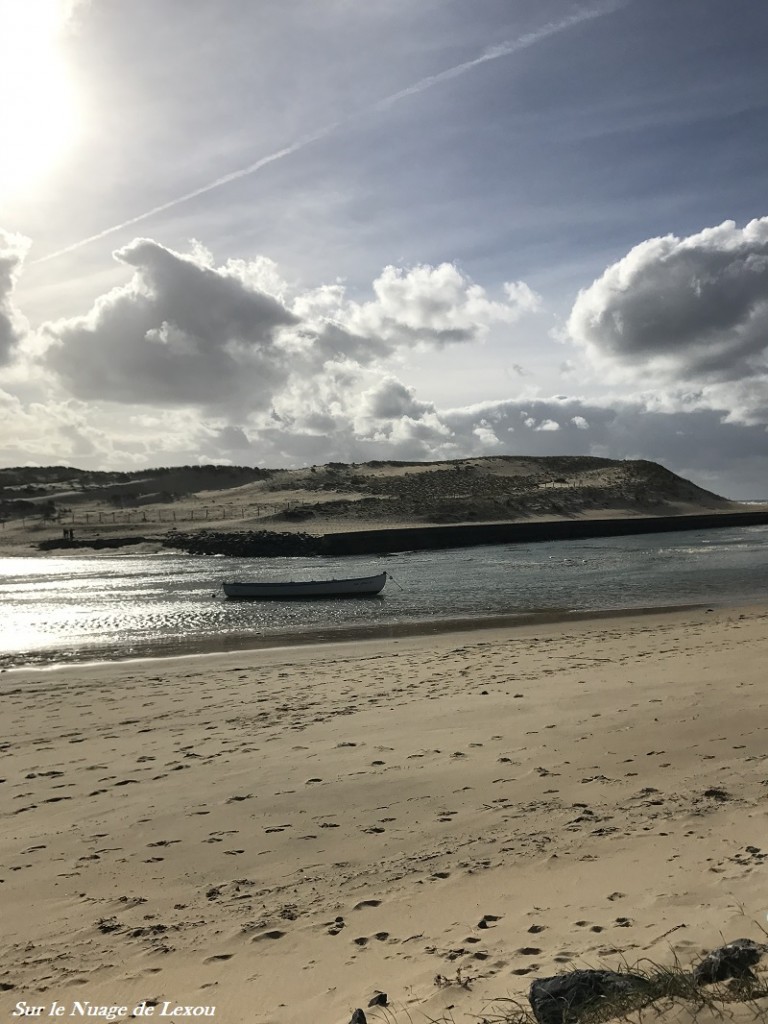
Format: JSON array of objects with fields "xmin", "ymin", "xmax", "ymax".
[{"xmin": 568, "ymin": 217, "xmax": 768, "ymax": 419}]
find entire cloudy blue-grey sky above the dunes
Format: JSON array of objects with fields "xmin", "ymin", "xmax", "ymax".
[{"xmin": 0, "ymin": 0, "xmax": 768, "ymax": 499}]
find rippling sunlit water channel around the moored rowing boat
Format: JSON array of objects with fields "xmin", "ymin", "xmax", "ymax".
[{"xmin": 0, "ymin": 526, "xmax": 768, "ymax": 667}]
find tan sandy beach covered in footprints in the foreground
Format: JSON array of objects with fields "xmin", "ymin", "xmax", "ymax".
[{"xmin": 0, "ymin": 607, "xmax": 768, "ymax": 1024}]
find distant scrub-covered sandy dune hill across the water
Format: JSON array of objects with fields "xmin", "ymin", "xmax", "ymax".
[{"xmin": 0, "ymin": 456, "xmax": 741, "ymax": 532}]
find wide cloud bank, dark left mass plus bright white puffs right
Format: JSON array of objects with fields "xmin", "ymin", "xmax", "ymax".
[{"xmin": 41, "ymin": 239, "xmax": 539, "ymax": 415}]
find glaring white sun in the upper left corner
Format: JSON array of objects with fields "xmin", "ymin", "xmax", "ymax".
[{"xmin": 0, "ymin": 0, "xmax": 80, "ymax": 201}]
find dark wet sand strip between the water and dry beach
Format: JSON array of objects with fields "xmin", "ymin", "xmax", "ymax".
[{"xmin": 0, "ymin": 601, "xmax": 720, "ymax": 675}]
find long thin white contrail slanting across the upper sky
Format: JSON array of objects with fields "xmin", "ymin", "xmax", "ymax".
[{"xmin": 30, "ymin": 0, "xmax": 630, "ymax": 263}]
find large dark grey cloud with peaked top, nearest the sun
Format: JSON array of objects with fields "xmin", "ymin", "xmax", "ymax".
[{"xmin": 45, "ymin": 240, "xmax": 298, "ymax": 412}]
